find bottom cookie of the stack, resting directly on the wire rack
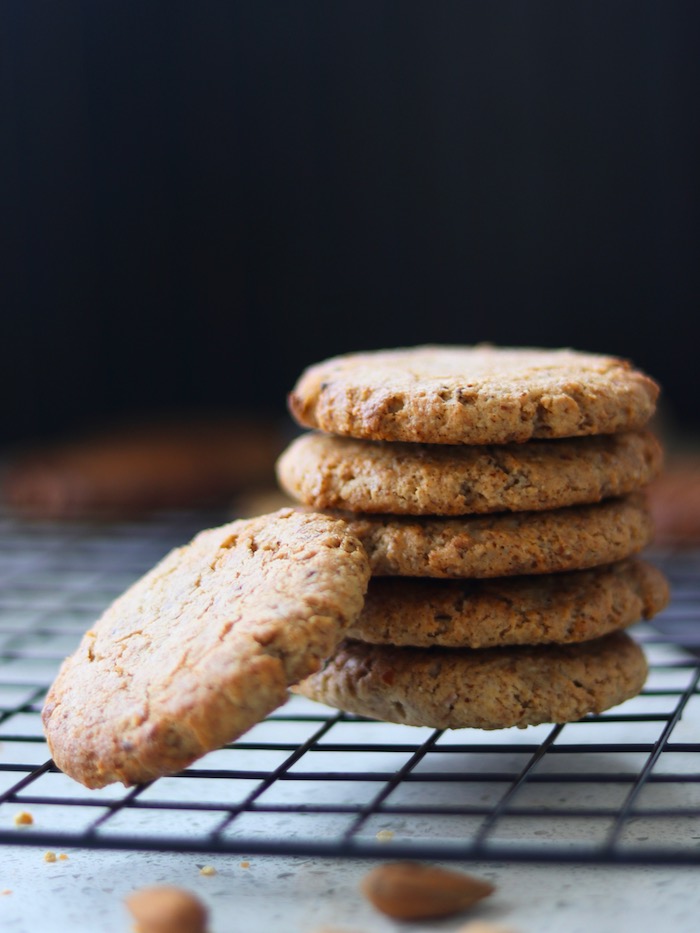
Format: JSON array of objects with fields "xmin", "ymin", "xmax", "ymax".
[{"xmin": 294, "ymin": 632, "xmax": 647, "ymax": 729}]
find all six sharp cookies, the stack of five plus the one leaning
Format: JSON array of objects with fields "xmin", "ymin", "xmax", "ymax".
[{"xmin": 42, "ymin": 347, "xmax": 667, "ymax": 787}]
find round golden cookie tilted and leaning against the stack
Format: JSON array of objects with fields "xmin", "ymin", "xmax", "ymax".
[{"xmin": 42, "ymin": 509, "xmax": 369, "ymax": 787}]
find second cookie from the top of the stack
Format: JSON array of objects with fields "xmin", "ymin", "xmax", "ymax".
[{"xmin": 277, "ymin": 431, "xmax": 663, "ymax": 515}]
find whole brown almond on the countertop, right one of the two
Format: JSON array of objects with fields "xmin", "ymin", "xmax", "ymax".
[{"xmin": 361, "ymin": 862, "xmax": 494, "ymax": 920}]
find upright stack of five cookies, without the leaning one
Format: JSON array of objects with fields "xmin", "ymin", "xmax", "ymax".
[{"xmin": 278, "ymin": 347, "xmax": 668, "ymax": 729}]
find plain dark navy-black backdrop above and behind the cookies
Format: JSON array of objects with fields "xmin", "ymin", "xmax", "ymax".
[{"xmin": 0, "ymin": 0, "xmax": 700, "ymax": 442}]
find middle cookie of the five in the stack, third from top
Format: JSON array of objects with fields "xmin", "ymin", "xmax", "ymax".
[{"xmin": 329, "ymin": 493, "xmax": 653, "ymax": 578}]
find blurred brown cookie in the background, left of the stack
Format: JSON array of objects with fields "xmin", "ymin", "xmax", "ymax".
[{"xmin": 2, "ymin": 416, "xmax": 287, "ymax": 519}]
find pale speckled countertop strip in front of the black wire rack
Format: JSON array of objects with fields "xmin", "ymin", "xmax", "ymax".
[{"xmin": 0, "ymin": 847, "xmax": 700, "ymax": 933}]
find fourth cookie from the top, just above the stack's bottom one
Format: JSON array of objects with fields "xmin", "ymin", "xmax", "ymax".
[{"xmin": 347, "ymin": 558, "xmax": 669, "ymax": 648}]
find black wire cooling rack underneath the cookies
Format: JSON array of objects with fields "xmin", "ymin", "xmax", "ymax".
[{"xmin": 0, "ymin": 502, "xmax": 700, "ymax": 864}]
